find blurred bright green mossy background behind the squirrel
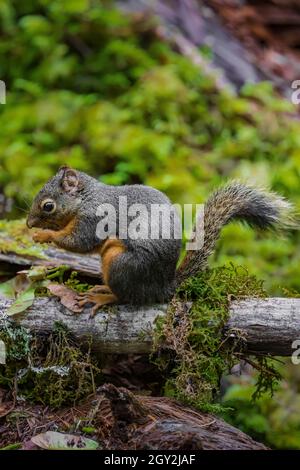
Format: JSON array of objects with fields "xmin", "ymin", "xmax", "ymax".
[{"xmin": 0, "ymin": 0, "xmax": 300, "ymax": 448}]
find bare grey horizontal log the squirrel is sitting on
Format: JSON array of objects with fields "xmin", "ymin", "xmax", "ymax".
[{"xmin": 0, "ymin": 297, "xmax": 300, "ymax": 356}]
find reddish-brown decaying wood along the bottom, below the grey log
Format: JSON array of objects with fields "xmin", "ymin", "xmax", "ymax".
[{"xmin": 83, "ymin": 384, "xmax": 266, "ymax": 450}]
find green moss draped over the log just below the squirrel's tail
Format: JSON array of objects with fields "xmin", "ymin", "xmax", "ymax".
[{"xmin": 153, "ymin": 265, "xmax": 278, "ymax": 412}]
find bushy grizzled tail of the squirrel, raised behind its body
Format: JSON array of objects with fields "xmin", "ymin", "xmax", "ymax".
[{"xmin": 176, "ymin": 182, "xmax": 295, "ymax": 285}]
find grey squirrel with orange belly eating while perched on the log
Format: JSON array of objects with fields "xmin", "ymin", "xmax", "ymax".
[{"xmin": 27, "ymin": 166, "xmax": 291, "ymax": 316}]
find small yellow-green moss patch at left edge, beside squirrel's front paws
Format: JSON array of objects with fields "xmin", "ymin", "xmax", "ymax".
[{"xmin": 0, "ymin": 219, "xmax": 47, "ymax": 259}]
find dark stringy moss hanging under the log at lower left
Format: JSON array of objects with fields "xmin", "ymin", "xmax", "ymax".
[{"xmin": 0, "ymin": 323, "xmax": 100, "ymax": 408}]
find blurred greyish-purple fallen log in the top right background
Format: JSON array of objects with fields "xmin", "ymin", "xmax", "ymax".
[{"xmin": 118, "ymin": 0, "xmax": 298, "ymax": 99}]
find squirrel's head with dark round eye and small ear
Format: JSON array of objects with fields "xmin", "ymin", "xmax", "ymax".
[{"xmin": 26, "ymin": 167, "xmax": 82, "ymax": 230}]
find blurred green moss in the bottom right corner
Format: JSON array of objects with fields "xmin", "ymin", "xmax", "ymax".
[{"xmin": 222, "ymin": 357, "xmax": 300, "ymax": 449}]
